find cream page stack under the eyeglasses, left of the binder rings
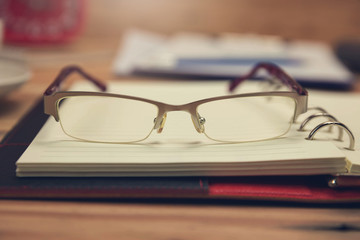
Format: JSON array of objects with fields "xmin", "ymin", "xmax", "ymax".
[{"xmin": 17, "ymin": 82, "xmax": 345, "ymax": 175}]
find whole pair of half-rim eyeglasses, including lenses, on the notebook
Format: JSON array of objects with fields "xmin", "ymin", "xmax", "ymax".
[{"xmin": 44, "ymin": 63, "xmax": 308, "ymax": 143}]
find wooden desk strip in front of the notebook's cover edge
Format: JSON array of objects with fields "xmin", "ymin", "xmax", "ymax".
[{"xmin": 0, "ymin": 201, "xmax": 360, "ymax": 240}]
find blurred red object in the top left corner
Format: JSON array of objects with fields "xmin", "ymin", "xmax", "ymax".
[{"xmin": 0, "ymin": 0, "xmax": 86, "ymax": 43}]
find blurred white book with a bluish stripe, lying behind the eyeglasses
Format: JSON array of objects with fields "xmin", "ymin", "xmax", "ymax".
[{"xmin": 113, "ymin": 30, "xmax": 355, "ymax": 89}]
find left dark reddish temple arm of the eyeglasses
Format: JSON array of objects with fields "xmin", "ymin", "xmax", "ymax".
[{"xmin": 44, "ymin": 66, "xmax": 106, "ymax": 95}]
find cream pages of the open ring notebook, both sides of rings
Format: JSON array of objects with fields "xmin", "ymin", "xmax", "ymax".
[{"xmin": 16, "ymin": 82, "xmax": 360, "ymax": 176}]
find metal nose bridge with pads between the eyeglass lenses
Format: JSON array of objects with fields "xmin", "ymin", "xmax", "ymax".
[{"xmin": 154, "ymin": 104, "xmax": 205, "ymax": 133}]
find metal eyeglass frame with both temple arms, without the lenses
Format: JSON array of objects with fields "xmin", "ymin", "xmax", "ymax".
[{"xmin": 44, "ymin": 63, "xmax": 308, "ymax": 143}]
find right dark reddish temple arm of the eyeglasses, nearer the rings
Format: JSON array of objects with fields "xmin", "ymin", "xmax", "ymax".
[{"xmin": 229, "ymin": 63, "xmax": 307, "ymax": 95}]
